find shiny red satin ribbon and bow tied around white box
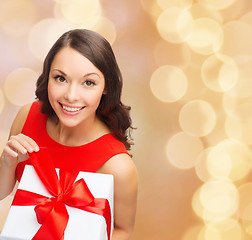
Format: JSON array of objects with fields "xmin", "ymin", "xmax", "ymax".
[{"xmin": 12, "ymin": 150, "xmax": 111, "ymax": 240}]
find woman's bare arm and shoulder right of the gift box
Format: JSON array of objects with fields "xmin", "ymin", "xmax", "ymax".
[{"xmin": 99, "ymin": 154, "xmax": 138, "ymax": 240}]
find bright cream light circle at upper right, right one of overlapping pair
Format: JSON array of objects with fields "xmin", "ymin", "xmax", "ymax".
[{"xmin": 187, "ymin": 18, "xmax": 223, "ymax": 55}]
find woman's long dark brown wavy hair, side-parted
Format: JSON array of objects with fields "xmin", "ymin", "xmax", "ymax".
[{"xmin": 35, "ymin": 29, "xmax": 132, "ymax": 150}]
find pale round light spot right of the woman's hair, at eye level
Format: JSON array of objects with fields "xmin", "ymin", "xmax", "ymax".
[{"xmin": 150, "ymin": 65, "xmax": 187, "ymax": 102}]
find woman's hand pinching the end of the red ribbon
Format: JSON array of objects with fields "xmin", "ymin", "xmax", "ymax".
[{"xmin": 3, "ymin": 133, "xmax": 39, "ymax": 166}]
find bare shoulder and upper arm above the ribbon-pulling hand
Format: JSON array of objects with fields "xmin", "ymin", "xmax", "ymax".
[{"xmin": 10, "ymin": 103, "xmax": 32, "ymax": 136}]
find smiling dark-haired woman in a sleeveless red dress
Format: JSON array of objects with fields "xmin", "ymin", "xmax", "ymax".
[{"xmin": 0, "ymin": 29, "xmax": 137, "ymax": 240}]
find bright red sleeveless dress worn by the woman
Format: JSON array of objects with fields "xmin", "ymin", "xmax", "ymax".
[{"xmin": 16, "ymin": 101, "xmax": 128, "ymax": 181}]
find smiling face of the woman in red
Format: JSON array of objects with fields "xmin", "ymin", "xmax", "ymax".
[{"xmin": 48, "ymin": 47, "xmax": 105, "ymax": 127}]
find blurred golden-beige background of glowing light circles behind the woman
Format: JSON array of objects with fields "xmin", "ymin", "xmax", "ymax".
[{"xmin": 0, "ymin": 0, "xmax": 252, "ymax": 240}]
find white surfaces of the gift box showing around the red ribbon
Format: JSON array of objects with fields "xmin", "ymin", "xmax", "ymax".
[{"xmin": 0, "ymin": 165, "xmax": 114, "ymax": 240}]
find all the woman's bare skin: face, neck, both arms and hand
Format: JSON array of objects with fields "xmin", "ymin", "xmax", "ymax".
[{"xmin": 0, "ymin": 47, "xmax": 138, "ymax": 240}]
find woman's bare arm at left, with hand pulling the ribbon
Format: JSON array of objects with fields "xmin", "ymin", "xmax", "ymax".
[{"xmin": 0, "ymin": 105, "xmax": 38, "ymax": 199}]
